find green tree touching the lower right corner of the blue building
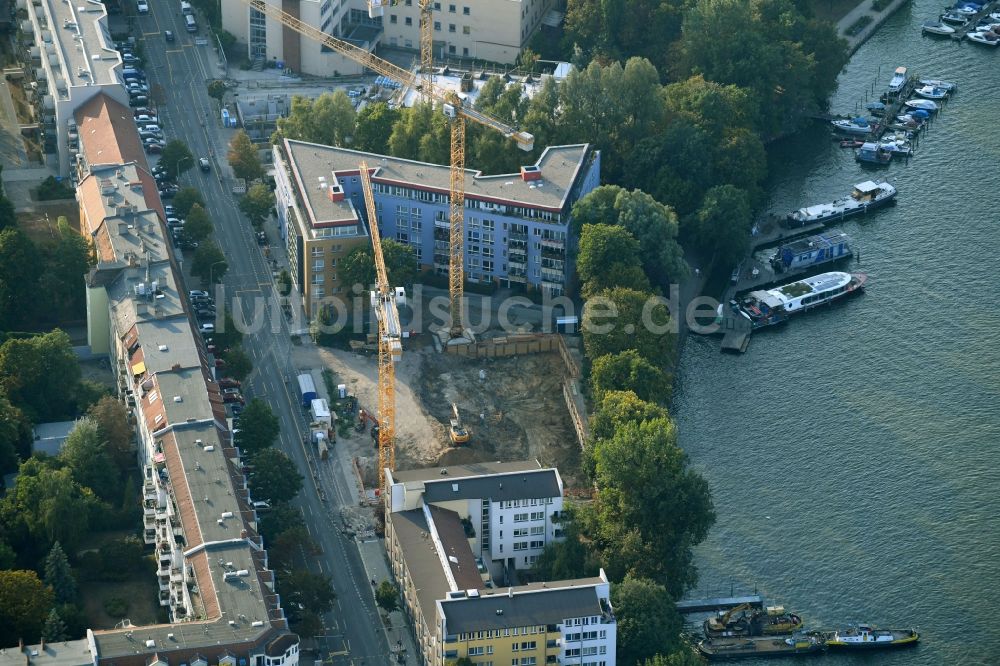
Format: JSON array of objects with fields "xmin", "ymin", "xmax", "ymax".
[{"xmin": 576, "ymin": 224, "xmax": 649, "ymax": 298}]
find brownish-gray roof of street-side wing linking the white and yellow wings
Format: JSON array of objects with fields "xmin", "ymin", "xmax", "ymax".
[{"xmin": 386, "ymin": 509, "xmax": 449, "ymax": 624}]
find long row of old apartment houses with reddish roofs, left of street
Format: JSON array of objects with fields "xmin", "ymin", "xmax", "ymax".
[{"xmin": 0, "ymin": 95, "xmax": 299, "ymax": 666}]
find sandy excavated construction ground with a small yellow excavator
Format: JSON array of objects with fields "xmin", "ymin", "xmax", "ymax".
[{"xmin": 293, "ymin": 336, "xmax": 582, "ymax": 487}]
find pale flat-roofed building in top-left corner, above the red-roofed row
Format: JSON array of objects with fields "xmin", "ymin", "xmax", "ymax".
[{"xmin": 17, "ymin": 0, "xmax": 128, "ymax": 176}]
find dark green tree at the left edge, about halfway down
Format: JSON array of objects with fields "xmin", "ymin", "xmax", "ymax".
[{"xmin": 0, "ymin": 329, "xmax": 80, "ymax": 422}]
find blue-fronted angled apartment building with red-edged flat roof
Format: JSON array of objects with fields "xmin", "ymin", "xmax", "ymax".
[{"xmin": 273, "ymin": 139, "xmax": 600, "ymax": 314}]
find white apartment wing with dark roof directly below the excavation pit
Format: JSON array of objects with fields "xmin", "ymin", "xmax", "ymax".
[{"xmin": 386, "ymin": 461, "xmax": 563, "ymax": 580}]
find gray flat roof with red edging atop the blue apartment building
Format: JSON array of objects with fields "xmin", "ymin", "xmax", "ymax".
[{"xmin": 285, "ymin": 139, "xmax": 588, "ymax": 211}]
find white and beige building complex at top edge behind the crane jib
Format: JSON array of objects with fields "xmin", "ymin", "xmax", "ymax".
[{"xmin": 222, "ymin": 0, "xmax": 555, "ymax": 76}]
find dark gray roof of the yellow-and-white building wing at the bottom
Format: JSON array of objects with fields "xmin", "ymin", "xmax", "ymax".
[{"xmin": 439, "ymin": 584, "xmax": 603, "ymax": 635}]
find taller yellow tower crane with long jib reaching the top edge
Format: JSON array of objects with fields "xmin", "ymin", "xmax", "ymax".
[{"xmin": 243, "ymin": 0, "xmax": 535, "ymax": 337}]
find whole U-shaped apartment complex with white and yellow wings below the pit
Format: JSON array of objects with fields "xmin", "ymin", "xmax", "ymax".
[{"xmin": 386, "ymin": 462, "xmax": 617, "ymax": 666}]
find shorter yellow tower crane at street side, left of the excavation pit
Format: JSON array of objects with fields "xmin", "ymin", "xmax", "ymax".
[{"xmin": 359, "ymin": 162, "xmax": 403, "ymax": 489}]
